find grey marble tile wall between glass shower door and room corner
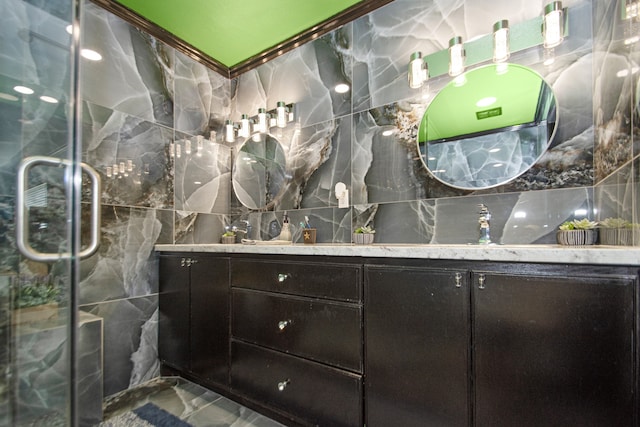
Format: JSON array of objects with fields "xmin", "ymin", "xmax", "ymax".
[{"xmin": 79, "ymin": 2, "xmax": 231, "ymax": 402}]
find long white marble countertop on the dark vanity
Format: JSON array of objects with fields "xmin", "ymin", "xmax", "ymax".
[{"xmin": 155, "ymin": 243, "xmax": 640, "ymax": 266}]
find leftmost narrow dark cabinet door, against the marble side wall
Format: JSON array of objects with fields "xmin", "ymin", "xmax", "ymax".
[{"xmin": 158, "ymin": 255, "xmax": 189, "ymax": 371}]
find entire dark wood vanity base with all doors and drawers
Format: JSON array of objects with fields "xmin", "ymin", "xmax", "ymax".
[{"xmin": 158, "ymin": 254, "xmax": 640, "ymax": 427}]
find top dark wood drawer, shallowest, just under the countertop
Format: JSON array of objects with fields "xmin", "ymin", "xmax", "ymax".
[{"xmin": 231, "ymin": 259, "xmax": 362, "ymax": 301}]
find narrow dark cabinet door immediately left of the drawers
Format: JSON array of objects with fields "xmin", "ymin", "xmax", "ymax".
[{"xmin": 190, "ymin": 256, "xmax": 229, "ymax": 385}]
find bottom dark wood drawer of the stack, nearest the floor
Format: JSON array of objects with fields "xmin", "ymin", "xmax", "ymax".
[{"xmin": 231, "ymin": 341, "xmax": 362, "ymax": 426}]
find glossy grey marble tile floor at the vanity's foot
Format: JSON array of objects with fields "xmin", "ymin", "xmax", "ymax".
[{"xmin": 104, "ymin": 377, "xmax": 283, "ymax": 427}]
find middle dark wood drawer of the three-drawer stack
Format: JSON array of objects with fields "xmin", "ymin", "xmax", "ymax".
[{"xmin": 231, "ymin": 288, "xmax": 362, "ymax": 372}]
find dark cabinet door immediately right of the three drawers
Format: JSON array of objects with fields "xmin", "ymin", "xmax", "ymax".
[{"xmin": 365, "ymin": 266, "xmax": 469, "ymax": 427}]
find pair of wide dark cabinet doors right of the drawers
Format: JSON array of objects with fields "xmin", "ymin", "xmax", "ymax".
[{"xmin": 365, "ymin": 264, "xmax": 638, "ymax": 427}]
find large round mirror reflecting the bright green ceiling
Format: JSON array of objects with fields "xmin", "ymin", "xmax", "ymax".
[{"xmin": 418, "ymin": 64, "xmax": 556, "ymax": 190}]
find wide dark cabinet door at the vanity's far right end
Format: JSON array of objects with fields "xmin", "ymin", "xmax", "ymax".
[{"xmin": 472, "ymin": 273, "xmax": 635, "ymax": 427}]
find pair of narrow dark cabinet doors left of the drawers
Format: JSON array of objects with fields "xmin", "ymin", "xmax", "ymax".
[{"xmin": 158, "ymin": 254, "xmax": 229, "ymax": 388}]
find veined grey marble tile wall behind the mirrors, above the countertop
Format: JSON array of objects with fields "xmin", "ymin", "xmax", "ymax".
[{"xmin": 231, "ymin": 0, "xmax": 635, "ymax": 244}]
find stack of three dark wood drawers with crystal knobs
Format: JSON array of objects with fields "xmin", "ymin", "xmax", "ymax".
[{"xmin": 230, "ymin": 259, "xmax": 363, "ymax": 426}]
